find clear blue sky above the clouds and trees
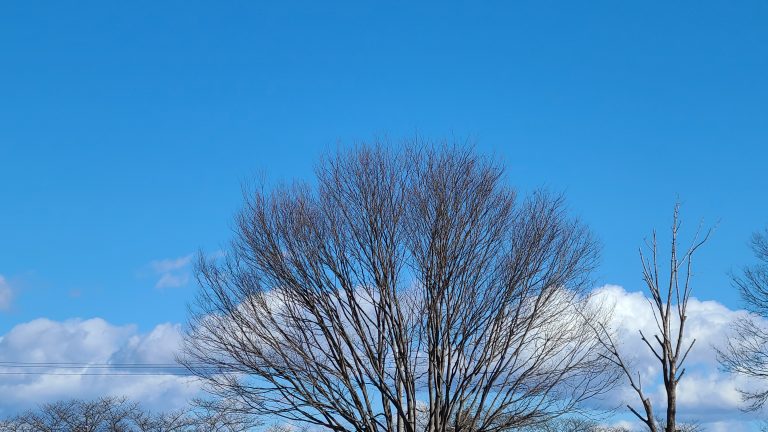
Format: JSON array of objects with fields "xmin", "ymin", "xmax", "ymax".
[{"xmin": 0, "ymin": 1, "xmax": 768, "ymax": 334}]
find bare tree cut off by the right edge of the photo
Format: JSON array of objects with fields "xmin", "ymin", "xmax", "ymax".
[{"xmin": 718, "ymin": 229, "xmax": 768, "ymax": 411}]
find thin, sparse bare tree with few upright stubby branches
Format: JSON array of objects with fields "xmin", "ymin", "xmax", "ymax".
[{"xmin": 596, "ymin": 204, "xmax": 711, "ymax": 432}]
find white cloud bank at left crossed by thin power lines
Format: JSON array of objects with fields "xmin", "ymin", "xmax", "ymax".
[{"xmin": 0, "ymin": 318, "xmax": 200, "ymax": 415}]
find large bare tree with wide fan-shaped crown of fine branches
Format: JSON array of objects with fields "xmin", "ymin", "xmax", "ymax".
[{"xmin": 183, "ymin": 144, "xmax": 615, "ymax": 432}]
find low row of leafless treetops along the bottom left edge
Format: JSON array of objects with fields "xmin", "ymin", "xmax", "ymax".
[{"xmin": 0, "ymin": 397, "xmax": 256, "ymax": 432}]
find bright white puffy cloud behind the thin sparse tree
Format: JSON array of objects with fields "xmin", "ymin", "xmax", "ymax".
[{"xmin": 595, "ymin": 285, "xmax": 755, "ymax": 430}]
